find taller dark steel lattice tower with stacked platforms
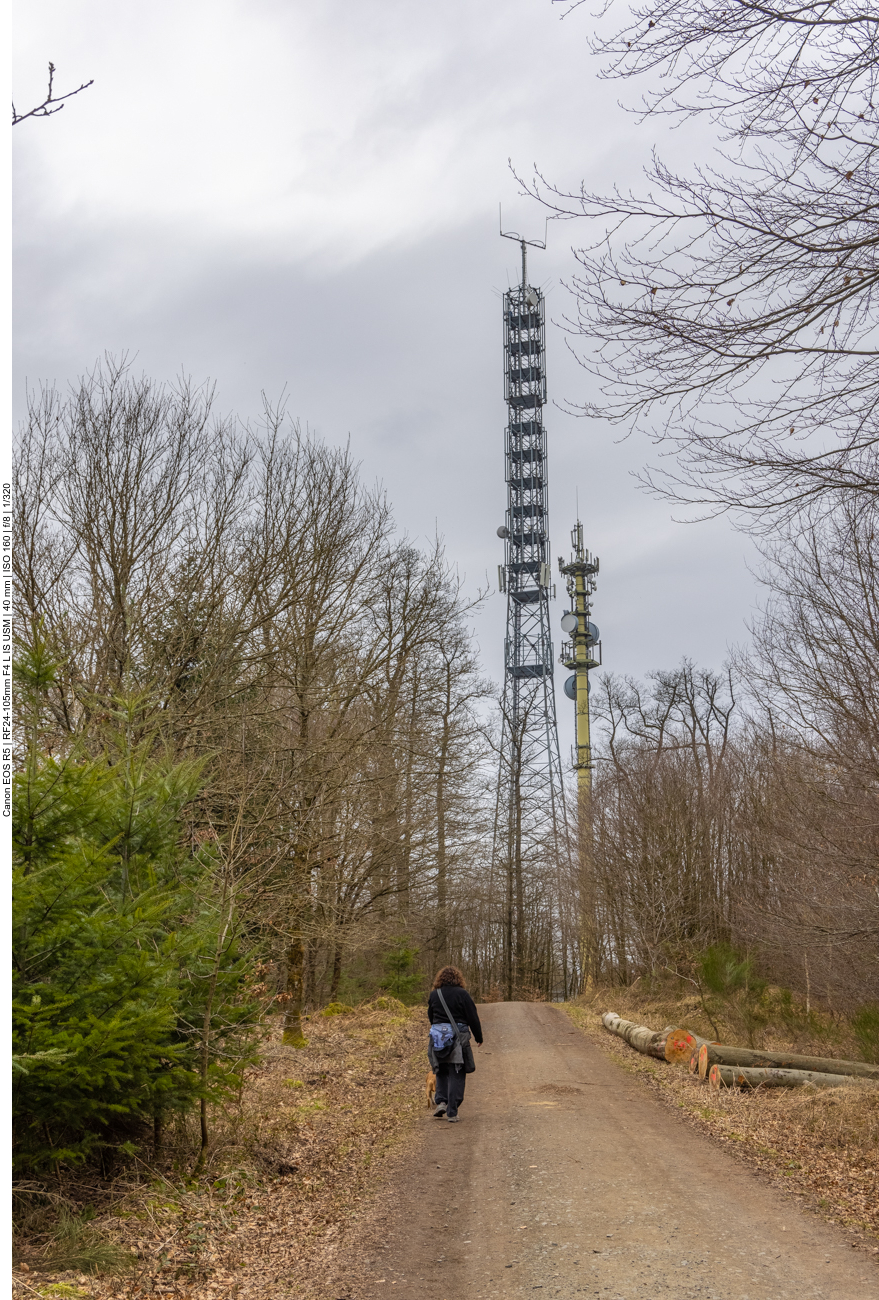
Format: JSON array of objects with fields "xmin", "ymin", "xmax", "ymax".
[{"xmin": 493, "ymin": 231, "xmax": 567, "ymax": 997}]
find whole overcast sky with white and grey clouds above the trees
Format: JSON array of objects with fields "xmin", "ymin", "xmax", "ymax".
[{"xmin": 13, "ymin": 0, "xmax": 757, "ymax": 751}]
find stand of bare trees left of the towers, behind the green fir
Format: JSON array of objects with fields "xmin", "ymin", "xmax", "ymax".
[{"xmin": 14, "ymin": 359, "xmax": 496, "ymax": 1024}]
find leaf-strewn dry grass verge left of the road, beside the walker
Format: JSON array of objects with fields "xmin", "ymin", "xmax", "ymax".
[{"xmin": 14, "ymin": 998, "xmax": 426, "ymax": 1300}]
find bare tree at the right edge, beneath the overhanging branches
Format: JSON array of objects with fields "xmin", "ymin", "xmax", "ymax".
[{"xmin": 742, "ymin": 494, "xmax": 879, "ymax": 1004}]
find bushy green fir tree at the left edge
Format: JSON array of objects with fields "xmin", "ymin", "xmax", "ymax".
[{"xmin": 13, "ymin": 649, "xmax": 252, "ymax": 1171}]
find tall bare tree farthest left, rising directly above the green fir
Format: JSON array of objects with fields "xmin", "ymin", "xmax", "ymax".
[{"xmin": 13, "ymin": 359, "xmax": 253, "ymax": 732}]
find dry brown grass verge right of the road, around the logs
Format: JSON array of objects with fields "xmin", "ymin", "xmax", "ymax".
[{"xmin": 563, "ymin": 989, "xmax": 879, "ymax": 1255}]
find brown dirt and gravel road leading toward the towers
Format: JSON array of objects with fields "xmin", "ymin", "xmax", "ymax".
[{"xmin": 328, "ymin": 1002, "xmax": 879, "ymax": 1300}]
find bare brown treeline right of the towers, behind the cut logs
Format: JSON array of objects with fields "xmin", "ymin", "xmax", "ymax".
[{"xmin": 584, "ymin": 512, "xmax": 879, "ymax": 1011}]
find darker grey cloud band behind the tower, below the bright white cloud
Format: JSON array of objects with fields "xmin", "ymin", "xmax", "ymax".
[{"xmin": 17, "ymin": 211, "xmax": 753, "ymax": 702}]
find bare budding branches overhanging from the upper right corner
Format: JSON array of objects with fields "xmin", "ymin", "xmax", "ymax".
[{"xmin": 528, "ymin": 0, "xmax": 879, "ymax": 528}]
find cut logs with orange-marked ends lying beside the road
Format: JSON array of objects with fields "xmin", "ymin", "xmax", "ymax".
[{"xmin": 601, "ymin": 1011, "xmax": 879, "ymax": 1089}]
